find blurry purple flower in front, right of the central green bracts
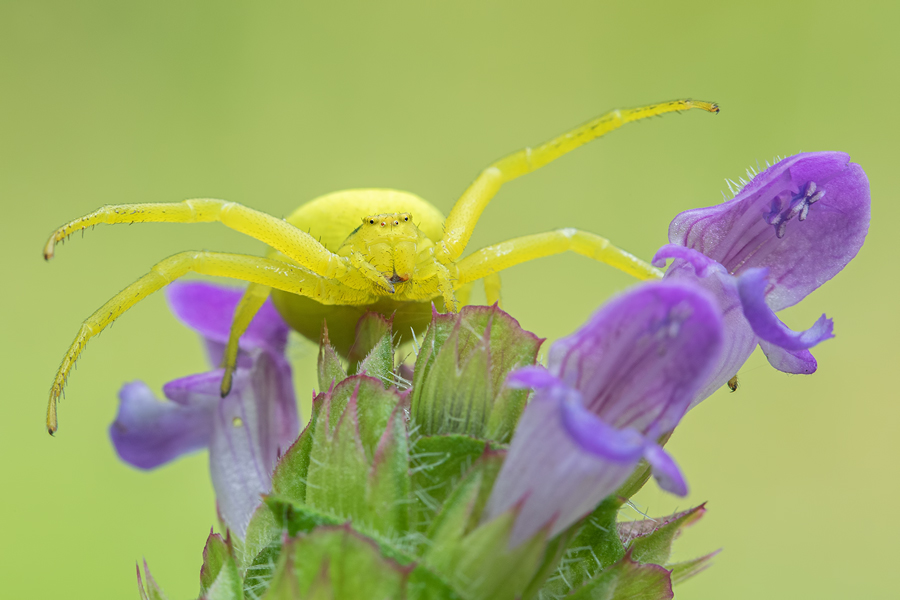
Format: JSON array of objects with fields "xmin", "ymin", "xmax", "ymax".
[{"xmin": 486, "ymin": 282, "xmax": 722, "ymax": 545}]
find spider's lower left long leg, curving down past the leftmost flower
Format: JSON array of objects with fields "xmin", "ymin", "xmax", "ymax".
[{"xmin": 47, "ymin": 252, "xmax": 376, "ymax": 434}]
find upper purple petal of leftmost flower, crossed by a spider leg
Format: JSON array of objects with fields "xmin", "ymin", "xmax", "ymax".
[{"xmin": 166, "ymin": 281, "xmax": 289, "ymax": 365}]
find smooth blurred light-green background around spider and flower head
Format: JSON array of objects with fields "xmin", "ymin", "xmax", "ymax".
[{"xmin": 0, "ymin": 0, "xmax": 900, "ymax": 600}]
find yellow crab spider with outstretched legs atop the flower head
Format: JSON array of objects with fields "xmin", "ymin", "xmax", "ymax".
[{"xmin": 44, "ymin": 99, "xmax": 719, "ymax": 434}]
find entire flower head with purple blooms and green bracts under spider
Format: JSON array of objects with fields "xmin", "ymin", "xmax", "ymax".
[{"xmin": 118, "ymin": 152, "xmax": 870, "ymax": 600}]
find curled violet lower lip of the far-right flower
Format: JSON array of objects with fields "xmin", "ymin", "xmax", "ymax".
[{"xmin": 737, "ymin": 269, "xmax": 834, "ymax": 351}]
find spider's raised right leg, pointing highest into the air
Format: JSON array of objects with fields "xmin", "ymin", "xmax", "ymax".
[{"xmin": 437, "ymin": 99, "xmax": 719, "ymax": 262}]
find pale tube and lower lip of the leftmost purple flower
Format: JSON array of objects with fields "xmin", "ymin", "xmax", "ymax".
[{"xmin": 110, "ymin": 351, "xmax": 299, "ymax": 538}]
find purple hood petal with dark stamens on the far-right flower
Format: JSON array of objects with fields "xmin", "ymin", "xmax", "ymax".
[{"xmin": 669, "ymin": 152, "xmax": 870, "ymax": 311}]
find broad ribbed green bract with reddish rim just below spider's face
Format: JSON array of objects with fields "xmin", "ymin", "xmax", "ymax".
[{"xmin": 410, "ymin": 305, "xmax": 543, "ymax": 443}]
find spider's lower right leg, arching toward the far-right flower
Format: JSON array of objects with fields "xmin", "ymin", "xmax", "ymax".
[{"xmin": 456, "ymin": 229, "xmax": 662, "ymax": 288}]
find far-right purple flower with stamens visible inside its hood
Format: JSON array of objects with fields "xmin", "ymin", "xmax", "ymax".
[{"xmin": 653, "ymin": 152, "xmax": 870, "ymax": 404}]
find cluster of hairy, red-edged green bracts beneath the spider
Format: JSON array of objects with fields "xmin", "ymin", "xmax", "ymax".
[{"xmin": 141, "ymin": 307, "xmax": 712, "ymax": 600}]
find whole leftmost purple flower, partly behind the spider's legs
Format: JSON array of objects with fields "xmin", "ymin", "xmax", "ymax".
[{"xmin": 109, "ymin": 282, "xmax": 299, "ymax": 538}]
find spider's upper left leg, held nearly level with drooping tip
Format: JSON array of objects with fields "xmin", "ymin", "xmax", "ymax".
[{"xmin": 44, "ymin": 198, "xmax": 350, "ymax": 278}]
